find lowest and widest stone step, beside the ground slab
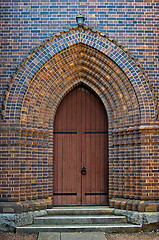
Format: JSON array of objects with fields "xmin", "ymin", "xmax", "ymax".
[{"xmin": 17, "ymin": 223, "xmax": 141, "ymax": 234}]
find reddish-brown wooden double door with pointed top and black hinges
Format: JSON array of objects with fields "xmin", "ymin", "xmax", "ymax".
[{"xmin": 53, "ymin": 86, "xmax": 108, "ymax": 205}]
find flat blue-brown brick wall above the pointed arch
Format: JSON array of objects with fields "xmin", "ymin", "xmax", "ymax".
[{"xmin": 0, "ymin": 0, "xmax": 159, "ymax": 112}]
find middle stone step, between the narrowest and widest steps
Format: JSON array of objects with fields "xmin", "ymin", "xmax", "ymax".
[{"xmin": 34, "ymin": 215, "xmax": 127, "ymax": 225}]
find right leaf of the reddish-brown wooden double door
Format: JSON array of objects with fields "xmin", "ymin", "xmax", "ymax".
[{"xmin": 82, "ymin": 87, "xmax": 108, "ymax": 205}]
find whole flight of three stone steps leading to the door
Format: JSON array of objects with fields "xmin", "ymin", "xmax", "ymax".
[{"xmin": 17, "ymin": 206, "xmax": 141, "ymax": 234}]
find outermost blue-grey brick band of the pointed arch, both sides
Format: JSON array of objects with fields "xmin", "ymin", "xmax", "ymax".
[{"xmin": 4, "ymin": 28, "xmax": 155, "ymax": 121}]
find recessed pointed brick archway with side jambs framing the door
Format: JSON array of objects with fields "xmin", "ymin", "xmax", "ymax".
[{"xmin": 0, "ymin": 28, "xmax": 157, "ymax": 213}]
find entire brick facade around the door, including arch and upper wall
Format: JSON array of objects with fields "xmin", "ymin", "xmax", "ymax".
[{"xmin": 0, "ymin": 1, "xmax": 159, "ymax": 214}]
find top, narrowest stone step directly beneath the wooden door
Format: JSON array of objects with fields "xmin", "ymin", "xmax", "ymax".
[{"xmin": 47, "ymin": 206, "xmax": 114, "ymax": 215}]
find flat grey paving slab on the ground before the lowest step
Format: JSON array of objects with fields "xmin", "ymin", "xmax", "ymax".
[{"xmin": 38, "ymin": 232, "xmax": 106, "ymax": 240}]
